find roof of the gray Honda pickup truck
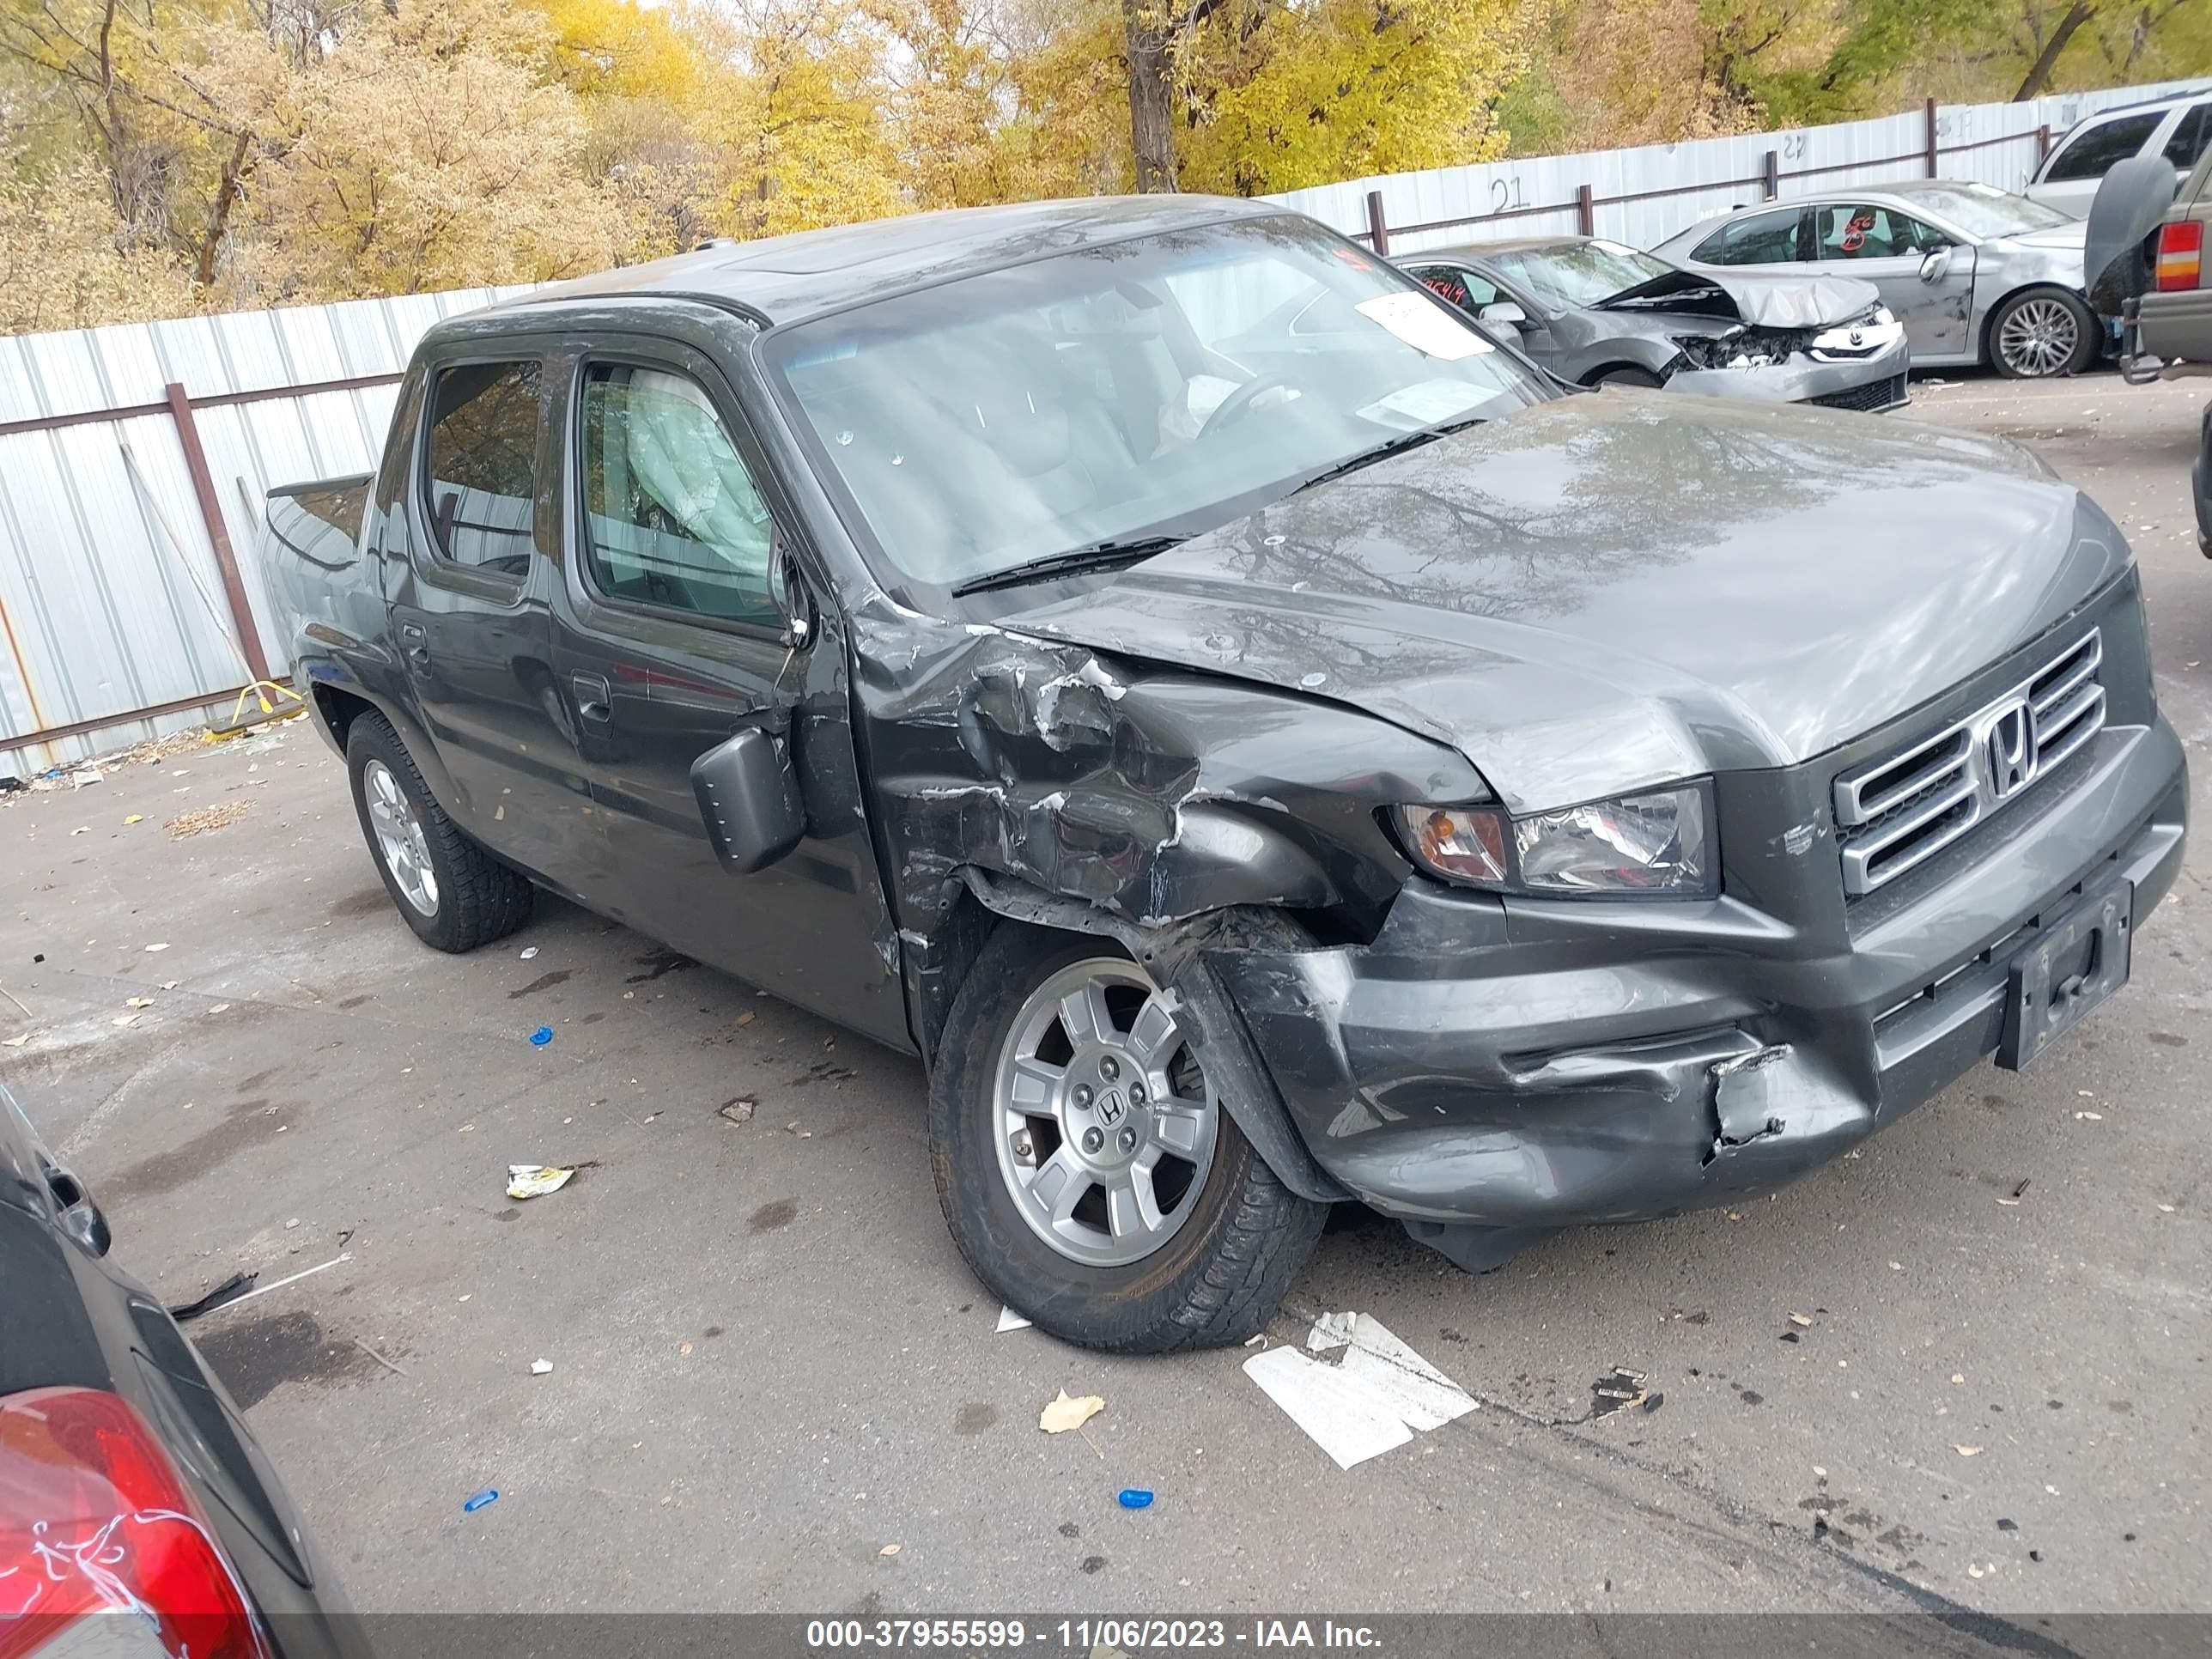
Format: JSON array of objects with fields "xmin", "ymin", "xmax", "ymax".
[{"xmin": 475, "ymin": 195, "xmax": 1290, "ymax": 325}]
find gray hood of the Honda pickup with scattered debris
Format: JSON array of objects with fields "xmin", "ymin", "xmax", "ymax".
[{"xmin": 1000, "ymin": 392, "xmax": 2128, "ymax": 811}]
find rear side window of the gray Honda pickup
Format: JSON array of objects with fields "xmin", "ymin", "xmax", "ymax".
[{"xmin": 422, "ymin": 362, "xmax": 542, "ymax": 581}]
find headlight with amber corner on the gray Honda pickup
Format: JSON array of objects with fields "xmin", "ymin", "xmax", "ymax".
[{"xmin": 1398, "ymin": 783, "xmax": 1721, "ymax": 898}]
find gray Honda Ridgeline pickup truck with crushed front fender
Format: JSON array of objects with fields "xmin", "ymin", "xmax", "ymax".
[{"xmin": 268, "ymin": 197, "xmax": 2185, "ymax": 1349}]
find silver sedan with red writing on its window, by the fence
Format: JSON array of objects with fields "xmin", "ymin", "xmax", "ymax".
[{"xmin": 1652, "ymin": 179, "xmax": 2104, "ymax": 380}]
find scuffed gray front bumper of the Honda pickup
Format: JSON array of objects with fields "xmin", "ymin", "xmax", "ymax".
[{"xmin": 1212, "ymin": 641, "xmax": 2188, "ymax": 1228}]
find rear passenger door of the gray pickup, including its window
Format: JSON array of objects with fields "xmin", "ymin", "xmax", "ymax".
[{"xmin": 392, "ymin": 338, "xmax": 598, "ymax": 891}]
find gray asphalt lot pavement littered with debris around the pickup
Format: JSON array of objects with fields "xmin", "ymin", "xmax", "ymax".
[{"xmin": 0, "ymin": 376, "xmax": 2212, "ymax": 1631}]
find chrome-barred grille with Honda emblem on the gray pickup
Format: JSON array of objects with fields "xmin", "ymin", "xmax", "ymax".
[{"xmin": 1836, "ymin": 629, "xmax": 2104, "ymax": 898}]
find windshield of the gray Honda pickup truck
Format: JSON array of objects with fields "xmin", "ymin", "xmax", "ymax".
[{"xmin": 765, "ymin": 216, "xmax": 1548, "ymax": 586}]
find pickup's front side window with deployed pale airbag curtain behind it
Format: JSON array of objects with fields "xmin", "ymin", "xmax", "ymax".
[{"xmin": 581, "ymin": 362, "xmax": 776, "ymax": 626}]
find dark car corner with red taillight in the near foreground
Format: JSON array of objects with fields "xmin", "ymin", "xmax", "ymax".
[{"xmin": 0, "ymin": 1086, "xmax": 368, "ymax": 1659}]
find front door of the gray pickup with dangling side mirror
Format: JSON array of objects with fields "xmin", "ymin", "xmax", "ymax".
[{"xmin": 556, "ymin": 318, "xmax": 911, "ymax": 1046}]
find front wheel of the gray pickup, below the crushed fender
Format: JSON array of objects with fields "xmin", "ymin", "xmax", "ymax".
[{"xmin": 929, "ymin": 925, "xmax": 1328, "ymax": 1354}]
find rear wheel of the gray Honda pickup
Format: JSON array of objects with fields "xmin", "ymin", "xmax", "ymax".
[{"xmin": 345, "ymin": 714, "xmax": 535, "ymax": 953}]
